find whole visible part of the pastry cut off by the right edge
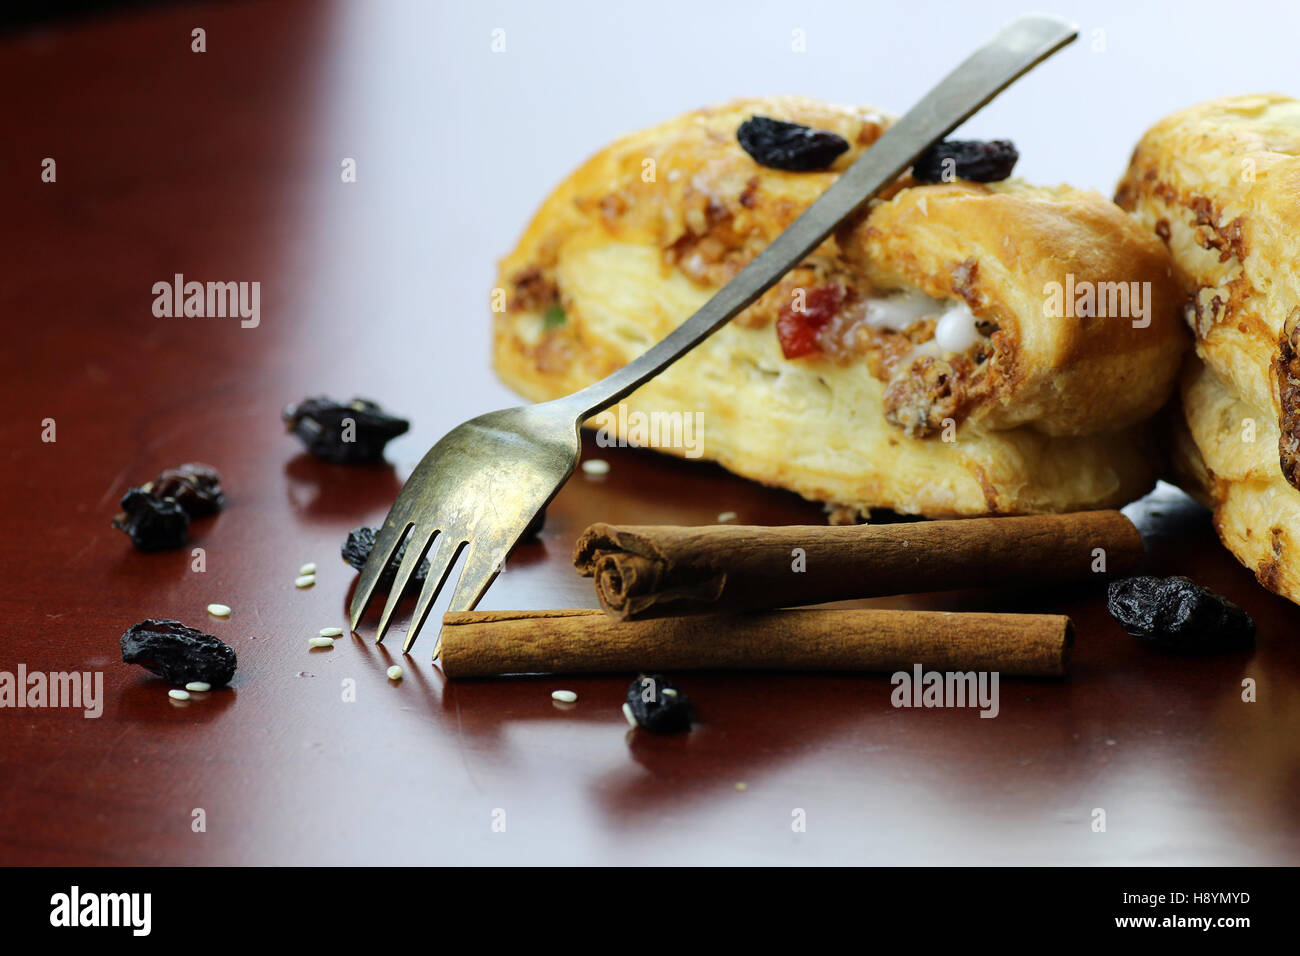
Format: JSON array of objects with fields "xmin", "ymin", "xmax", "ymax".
[{"xmin": 1117, "ymin": 94, "xmax": 1300, "ymax": 602}]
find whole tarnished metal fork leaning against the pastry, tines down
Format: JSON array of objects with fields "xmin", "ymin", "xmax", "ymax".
[{"xmin": 350, "ymin": 14, "xmax": 1078, "ymax": 658}]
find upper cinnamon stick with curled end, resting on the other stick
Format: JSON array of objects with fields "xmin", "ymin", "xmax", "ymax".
[{"xmin": 573, "ymin": 511, "xmax": 1143, "ymax": 620}]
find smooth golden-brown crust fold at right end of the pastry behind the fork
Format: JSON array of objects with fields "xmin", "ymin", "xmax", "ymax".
[{"xmin": 844, "ymin": 181, "xmax": 1184, "ymax": 434}]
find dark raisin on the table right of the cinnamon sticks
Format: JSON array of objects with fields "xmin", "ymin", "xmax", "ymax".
[{"xmin": 1106, "ymin": 576, "xmax": 1255, "ymax": 653}]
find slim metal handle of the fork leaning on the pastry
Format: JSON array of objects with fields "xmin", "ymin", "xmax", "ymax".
[{"xmin": 562, "ymin": 14, "xmax": 1078, "ymax": 420}]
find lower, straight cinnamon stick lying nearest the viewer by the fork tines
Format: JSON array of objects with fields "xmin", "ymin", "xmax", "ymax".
[{"xmin": 442, "ymin": 610, "xmax": 1073, "ymax": 678}]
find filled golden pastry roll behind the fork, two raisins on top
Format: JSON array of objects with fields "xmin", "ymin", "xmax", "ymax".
[{"xmin": 494, "ymin": 98, "xmax": 1187, "ymax": 516}]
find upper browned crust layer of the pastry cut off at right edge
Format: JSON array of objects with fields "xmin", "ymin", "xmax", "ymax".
[{"xmin": 1117, "ymin": 94, "xmax": 1300, "ymax": 481}]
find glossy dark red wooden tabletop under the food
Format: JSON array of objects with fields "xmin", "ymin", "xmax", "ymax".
[{"xmin": 0, "ymin": 4, "xmax": 1300, "ymax": 864}]
